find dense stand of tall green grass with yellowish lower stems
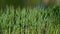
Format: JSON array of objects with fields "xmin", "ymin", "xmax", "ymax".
[{"xmin": 0, "ymin": 6, "xmax": 60, "ymax": 34}]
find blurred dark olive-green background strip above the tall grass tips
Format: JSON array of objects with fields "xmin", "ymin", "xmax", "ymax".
[{"xmin": 0, "ymin": 0, "xmax": 60, "ymax": 8}]
